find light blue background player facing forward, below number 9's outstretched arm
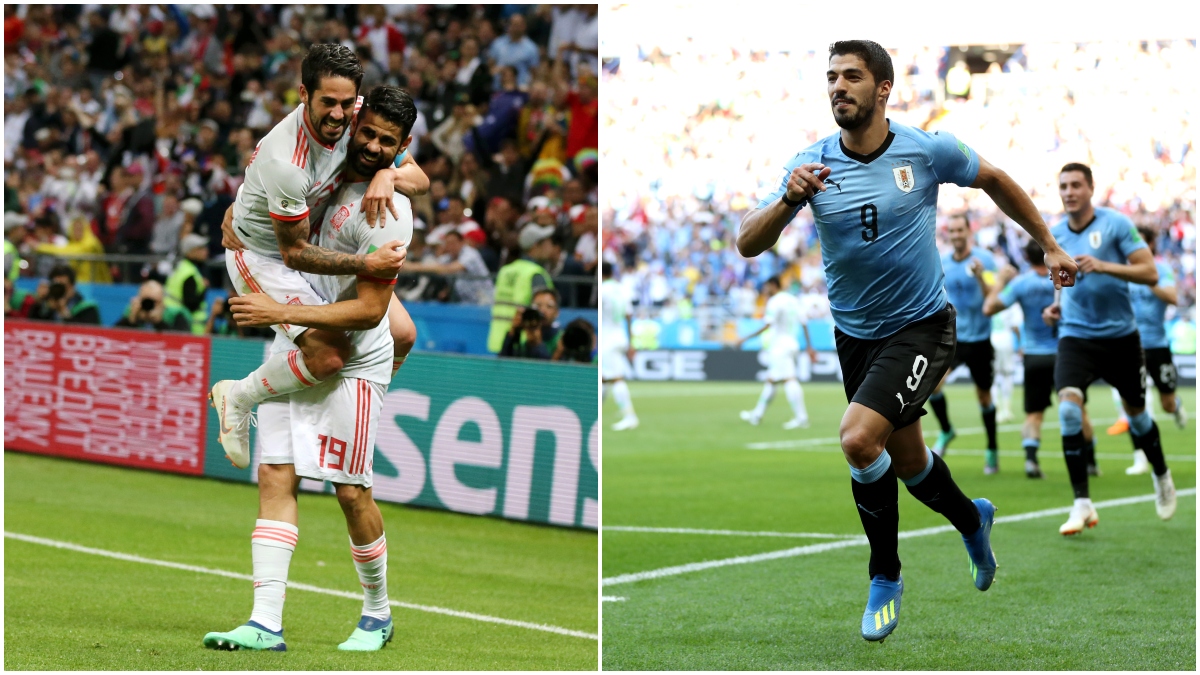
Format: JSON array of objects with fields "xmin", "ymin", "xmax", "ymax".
[{"xmin": 929, "ymin": 214, "xmax": 1000, "ymax": 473}]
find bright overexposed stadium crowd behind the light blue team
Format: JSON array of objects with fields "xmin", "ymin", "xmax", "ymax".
[{"xmin": 602, "ymin": 40, "xmax": 1196, "ymax": 331}]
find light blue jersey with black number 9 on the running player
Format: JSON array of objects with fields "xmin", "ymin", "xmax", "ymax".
[{"xmin": 758, "ymin": 121, "xmax": 979, "ymax": 340}]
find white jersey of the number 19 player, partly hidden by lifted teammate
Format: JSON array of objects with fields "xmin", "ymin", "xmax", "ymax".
[{"xmin": 272, "ymin": 181, "xmax": 413, "ymax": 386}]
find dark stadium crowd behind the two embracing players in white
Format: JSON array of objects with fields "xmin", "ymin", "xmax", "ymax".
[{"xmin": 4, "ymin": 4, "xmax": 599, "ymax": 330}]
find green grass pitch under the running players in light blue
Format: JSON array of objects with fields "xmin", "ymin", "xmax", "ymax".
[{"xmin": 601, "ymin": 383, "xmax": 1196, "ymax": 670}]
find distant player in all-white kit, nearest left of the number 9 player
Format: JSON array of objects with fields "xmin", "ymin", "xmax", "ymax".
[{"xmin": 737, "ymin": 276, "xmax": 817, "ymax": 429}]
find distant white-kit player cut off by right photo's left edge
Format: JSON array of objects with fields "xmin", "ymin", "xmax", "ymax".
[{"xmin": 600, "ymin": 262, "xmax": 638, "ymax": 431}]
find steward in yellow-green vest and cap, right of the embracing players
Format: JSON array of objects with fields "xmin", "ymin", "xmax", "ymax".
[{"xmin": 487, "ymin": 223, "xmax": 554, "ymax": 354}]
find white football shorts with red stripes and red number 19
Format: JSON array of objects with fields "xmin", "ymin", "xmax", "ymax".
[{"xmin": 258, "ymin": 377, "xmax": 388, "ymax": 488}]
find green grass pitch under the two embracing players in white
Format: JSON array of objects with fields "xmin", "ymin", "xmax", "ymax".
[{"xmin": 4, "ymin": 453, "xmax": 599, "ymax": 670}]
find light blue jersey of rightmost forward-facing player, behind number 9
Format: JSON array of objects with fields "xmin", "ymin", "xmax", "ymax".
[{"xmin": 1050, "ymin": 207, "xmax": 1146, "ymax": 340}]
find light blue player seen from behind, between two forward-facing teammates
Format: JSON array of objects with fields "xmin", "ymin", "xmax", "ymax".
[{"xmin": 983, "ymin": 241, "xmax": 1094, "ymax": 478}]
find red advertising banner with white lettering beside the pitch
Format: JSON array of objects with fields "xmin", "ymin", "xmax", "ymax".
[{"xmin": 4, "ymin": 321, "xmax": 209, "ymax": 474}]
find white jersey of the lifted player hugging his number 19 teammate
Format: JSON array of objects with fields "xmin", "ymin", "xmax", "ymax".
[{"xmin": 233, "ymin": 96, "xmax": 362, "ymax": 261}]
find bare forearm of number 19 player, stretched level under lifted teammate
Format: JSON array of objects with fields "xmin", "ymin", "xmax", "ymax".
[{"xmin": 229, "ymin": 279, "xmax": 392, "ymax": 330}]
